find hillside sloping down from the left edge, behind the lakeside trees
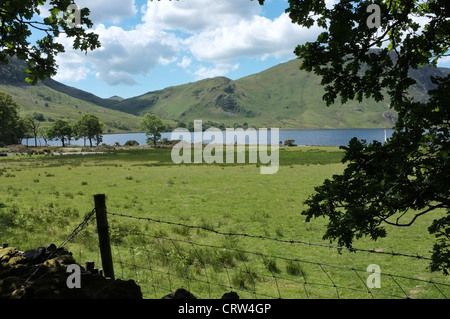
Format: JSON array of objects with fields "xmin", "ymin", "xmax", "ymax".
[{"xmin": 0, "ymin": 59, "xmax": 140, "ymax": 133}]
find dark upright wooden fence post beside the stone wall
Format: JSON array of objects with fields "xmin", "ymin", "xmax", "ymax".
[{"xmin": 94, "ymin": 194, "xmax": 114, "ymax": 279}]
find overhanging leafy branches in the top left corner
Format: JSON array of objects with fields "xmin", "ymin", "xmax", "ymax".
[{"xmin": 0, "ymin": 0, "xmax": 100, "ymax": 84}]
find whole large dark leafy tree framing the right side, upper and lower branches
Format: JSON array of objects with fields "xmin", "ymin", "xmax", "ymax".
[{"xmin": 255, "ymin": 0, "xmax": 450, "ymax": 274}]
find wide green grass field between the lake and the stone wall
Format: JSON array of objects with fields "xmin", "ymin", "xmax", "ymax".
[{"xmin": 0, "ymin": 147, "xmax": 450, "ymax": 298}]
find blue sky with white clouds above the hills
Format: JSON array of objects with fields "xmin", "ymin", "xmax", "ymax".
[{"xmin": 43, "ymin": 0, "xmax": 450, "ymax": 98}]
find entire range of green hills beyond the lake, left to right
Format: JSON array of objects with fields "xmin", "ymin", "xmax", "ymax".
[{"xmin": 0, "ymin": 59, "xmax": 450, "ymax": 132}]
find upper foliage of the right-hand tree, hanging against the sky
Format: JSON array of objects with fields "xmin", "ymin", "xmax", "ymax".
[{"xmin": 268, "ymin": 0, "xmax": 449, "ymax": 107}]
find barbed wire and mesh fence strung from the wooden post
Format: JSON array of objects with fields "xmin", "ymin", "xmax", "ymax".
[{"xmin": 29, "ymin": 195, "xmax": 450, "ymax": 299}]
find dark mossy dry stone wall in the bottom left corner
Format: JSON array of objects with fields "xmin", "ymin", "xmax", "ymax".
[{"xmin": 0, "ymin": 244, "xmax": 142, "ymax": 299}]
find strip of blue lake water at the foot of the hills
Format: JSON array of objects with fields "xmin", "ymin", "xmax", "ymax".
[{"xmin": 23, "ymin": 129, "xmax": 393, "ymax": 146}]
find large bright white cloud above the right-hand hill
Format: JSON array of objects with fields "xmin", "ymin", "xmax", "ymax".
[{"xmin": 143, "ymin": 0, "xmax": 322, "ymax": 69}]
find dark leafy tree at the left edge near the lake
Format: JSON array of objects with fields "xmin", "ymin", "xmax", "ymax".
[{"xmin": 0, "ymin": 92, "xmax": 24, "ymax": 145}]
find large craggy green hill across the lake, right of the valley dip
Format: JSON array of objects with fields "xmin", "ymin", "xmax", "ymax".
[{"xmin": 111, "ymin": 59, "xmax": 450, "ymax": 129}]
